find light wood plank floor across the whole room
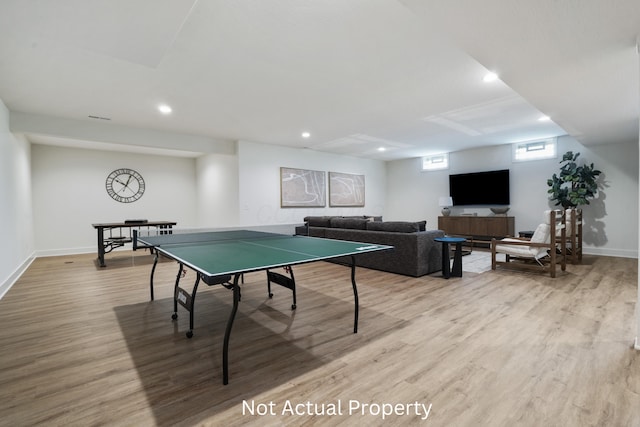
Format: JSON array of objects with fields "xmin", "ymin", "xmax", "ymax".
[{"xmin": 0, "ymin": 251, "xmax": 640, "ymax": 426}]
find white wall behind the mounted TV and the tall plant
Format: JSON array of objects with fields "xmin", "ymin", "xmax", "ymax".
[{"xmin": 386, "ymin": 137, "xmax": 639, "ymax": 257}]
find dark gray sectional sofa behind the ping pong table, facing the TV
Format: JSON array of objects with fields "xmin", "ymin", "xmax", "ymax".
[{"xmin": 296, "ymin": 216, "xmax": 444, "ymax": 277}]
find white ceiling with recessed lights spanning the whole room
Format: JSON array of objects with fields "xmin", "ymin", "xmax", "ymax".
[{"xmin": 0, "ymin": 0, "xmax": 640, "ymax": 160}]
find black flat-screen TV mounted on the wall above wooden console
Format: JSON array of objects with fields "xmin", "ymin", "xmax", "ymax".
[{"xmin": 449, "ymin": 169, "xmax": 509, "ymax": 206}]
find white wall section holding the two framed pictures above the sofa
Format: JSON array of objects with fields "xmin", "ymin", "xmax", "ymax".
[{"xmin": 238, "ymin": 141, "xmax": 386, "ymax": 225}]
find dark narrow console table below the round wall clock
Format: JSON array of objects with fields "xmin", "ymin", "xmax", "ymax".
[{"xmin": 91, "ymin": 220, "xmax": 177, "ymax": 267}]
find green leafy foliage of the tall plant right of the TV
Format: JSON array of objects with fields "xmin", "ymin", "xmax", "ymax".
[{"xmin": 547, "ymin": 151, "xmax": 601, "ymax": 209}]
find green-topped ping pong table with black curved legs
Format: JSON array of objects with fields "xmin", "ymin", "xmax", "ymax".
[{"xmin": 134, "ymin": 230, "xmax": 393, "ymax": 385}]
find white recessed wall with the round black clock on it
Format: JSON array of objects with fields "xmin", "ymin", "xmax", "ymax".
[{"xmin": 31, "ymin": 144, "xmax": 197, "ymax": 256}]
